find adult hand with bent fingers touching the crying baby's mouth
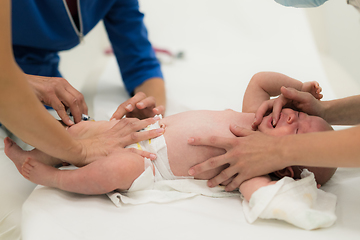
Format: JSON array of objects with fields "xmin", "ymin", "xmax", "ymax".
[{"xmin": 253, "ymin": 87, "xmax": 325, "ymax": 129}]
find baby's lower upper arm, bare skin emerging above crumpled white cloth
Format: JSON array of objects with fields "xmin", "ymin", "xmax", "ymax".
[{"xmin": 239, "ymin": 175, "xmax": 276, "ymax": 201}]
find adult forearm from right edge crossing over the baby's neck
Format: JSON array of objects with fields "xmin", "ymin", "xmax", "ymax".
[{"xmin": 278, "ymin": 126, "xmax": 360, "ymax": 167}]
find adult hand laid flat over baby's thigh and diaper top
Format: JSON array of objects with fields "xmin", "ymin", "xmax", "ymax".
[{"xmin": 76, "ymin": 118, "xmax": 164, "ymax": 166}]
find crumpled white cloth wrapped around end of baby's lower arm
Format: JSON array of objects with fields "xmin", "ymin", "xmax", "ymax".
[{"xmin": 242, "ymin": 169, "xmax": 337, "ymax": 230}]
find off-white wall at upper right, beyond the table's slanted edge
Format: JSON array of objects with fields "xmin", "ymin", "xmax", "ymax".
[{"xmin": 306, "ymin": 0, "xmax": 360, "ymax": 97}]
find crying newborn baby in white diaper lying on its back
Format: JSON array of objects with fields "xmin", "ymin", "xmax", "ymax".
[{"xmin": 5, "ymin": 72, "xmax": 336, "ymax": 200}]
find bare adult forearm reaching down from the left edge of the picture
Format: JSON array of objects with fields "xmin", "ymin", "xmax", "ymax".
[{"xmin": 0, "ymin": 63, "xmax": 82, "ymax": 162}]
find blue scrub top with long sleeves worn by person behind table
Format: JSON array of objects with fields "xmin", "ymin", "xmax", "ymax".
[{"xmin": 12, "ymin": 0, "xmax": 163, "ymax": 94}]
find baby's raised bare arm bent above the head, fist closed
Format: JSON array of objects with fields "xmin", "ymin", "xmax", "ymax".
[{"xmin": 242, "ymin": 72, "xmax": 322, "ymax": 112}]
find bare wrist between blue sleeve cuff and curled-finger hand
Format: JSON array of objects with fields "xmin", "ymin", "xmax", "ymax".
[{"xmin": 135, "ymin": 78, "xmax": 166, "ymax": 107}]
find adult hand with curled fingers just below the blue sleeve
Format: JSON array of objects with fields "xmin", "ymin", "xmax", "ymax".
[{"xmin": 111, "ymin": 92, "xmax": 165, "ymax": 119}]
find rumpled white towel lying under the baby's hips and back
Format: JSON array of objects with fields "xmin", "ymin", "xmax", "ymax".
[{"xmin": 107, "ymin": 167, "xmax": 240, "ymax": 207}]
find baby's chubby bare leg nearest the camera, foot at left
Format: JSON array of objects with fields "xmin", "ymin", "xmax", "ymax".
[{"xmin": 22, "ymin": 149, "xmax": 144, "ymax": 195}]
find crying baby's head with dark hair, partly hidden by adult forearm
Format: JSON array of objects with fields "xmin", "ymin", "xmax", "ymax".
[{"xmin": 258, "ymin": 108, "xmax": 336, "ymax": 185}]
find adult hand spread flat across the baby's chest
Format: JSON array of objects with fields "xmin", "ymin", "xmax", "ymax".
[{"xmin": 188, "ymin": 126, "xmax": 286, "ymax": 191}]
